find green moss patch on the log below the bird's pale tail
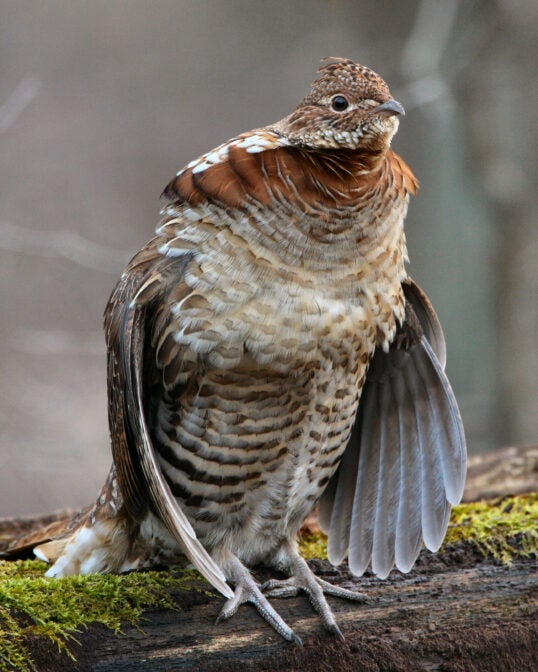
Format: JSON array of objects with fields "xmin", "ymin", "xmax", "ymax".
[{"xmin": 0, "ymin": 560, "xmax": 214, "ymax": 672}]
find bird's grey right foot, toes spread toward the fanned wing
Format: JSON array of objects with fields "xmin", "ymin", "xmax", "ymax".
[{"xmin": 261, "ymin": 543, "xmax": 368, "ymax": 639}]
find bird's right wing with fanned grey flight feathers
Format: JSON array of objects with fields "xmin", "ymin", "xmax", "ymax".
[{"xmin": 319, "ymin": 281, "xmax": 466, "ymax": 578}]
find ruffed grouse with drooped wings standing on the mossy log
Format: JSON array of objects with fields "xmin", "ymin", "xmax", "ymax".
[{"xmin": 5, "ymin": 58, "xmax": 466, "ymax": 644}]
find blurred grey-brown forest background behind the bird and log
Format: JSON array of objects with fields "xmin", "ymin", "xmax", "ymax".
[{"xmin": 0, "ymin": 0, "xmax": 538, "ymax": 516}]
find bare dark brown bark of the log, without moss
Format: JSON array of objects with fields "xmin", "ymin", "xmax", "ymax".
[{"xmin": 18, "ymin": 543, "xmax": 538, "ymax": 672}]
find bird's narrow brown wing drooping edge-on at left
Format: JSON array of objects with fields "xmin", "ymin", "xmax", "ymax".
[{"xmin": 105, "ymin": 244, "xmax": 233, "ymax": 597}]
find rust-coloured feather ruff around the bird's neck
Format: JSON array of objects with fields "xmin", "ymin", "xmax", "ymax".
[{"xmin": 164, "ymin": 133, "xmax": 418, "ymax": 218}]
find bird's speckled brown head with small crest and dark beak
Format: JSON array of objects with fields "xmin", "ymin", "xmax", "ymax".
[{"xmin": 275, "ymin": 58, "xmax": 404, "ymax": 152}]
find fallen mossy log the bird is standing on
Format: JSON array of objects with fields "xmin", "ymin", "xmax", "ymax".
[{"xmin": 0, "ymin": 446, "xmax": 538, "ymax": 672}]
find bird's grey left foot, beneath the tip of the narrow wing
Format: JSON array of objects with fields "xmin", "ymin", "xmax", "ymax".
[{"xmin": 217, "ymin": 555, "xmax": 302, "ymax": 646}]
